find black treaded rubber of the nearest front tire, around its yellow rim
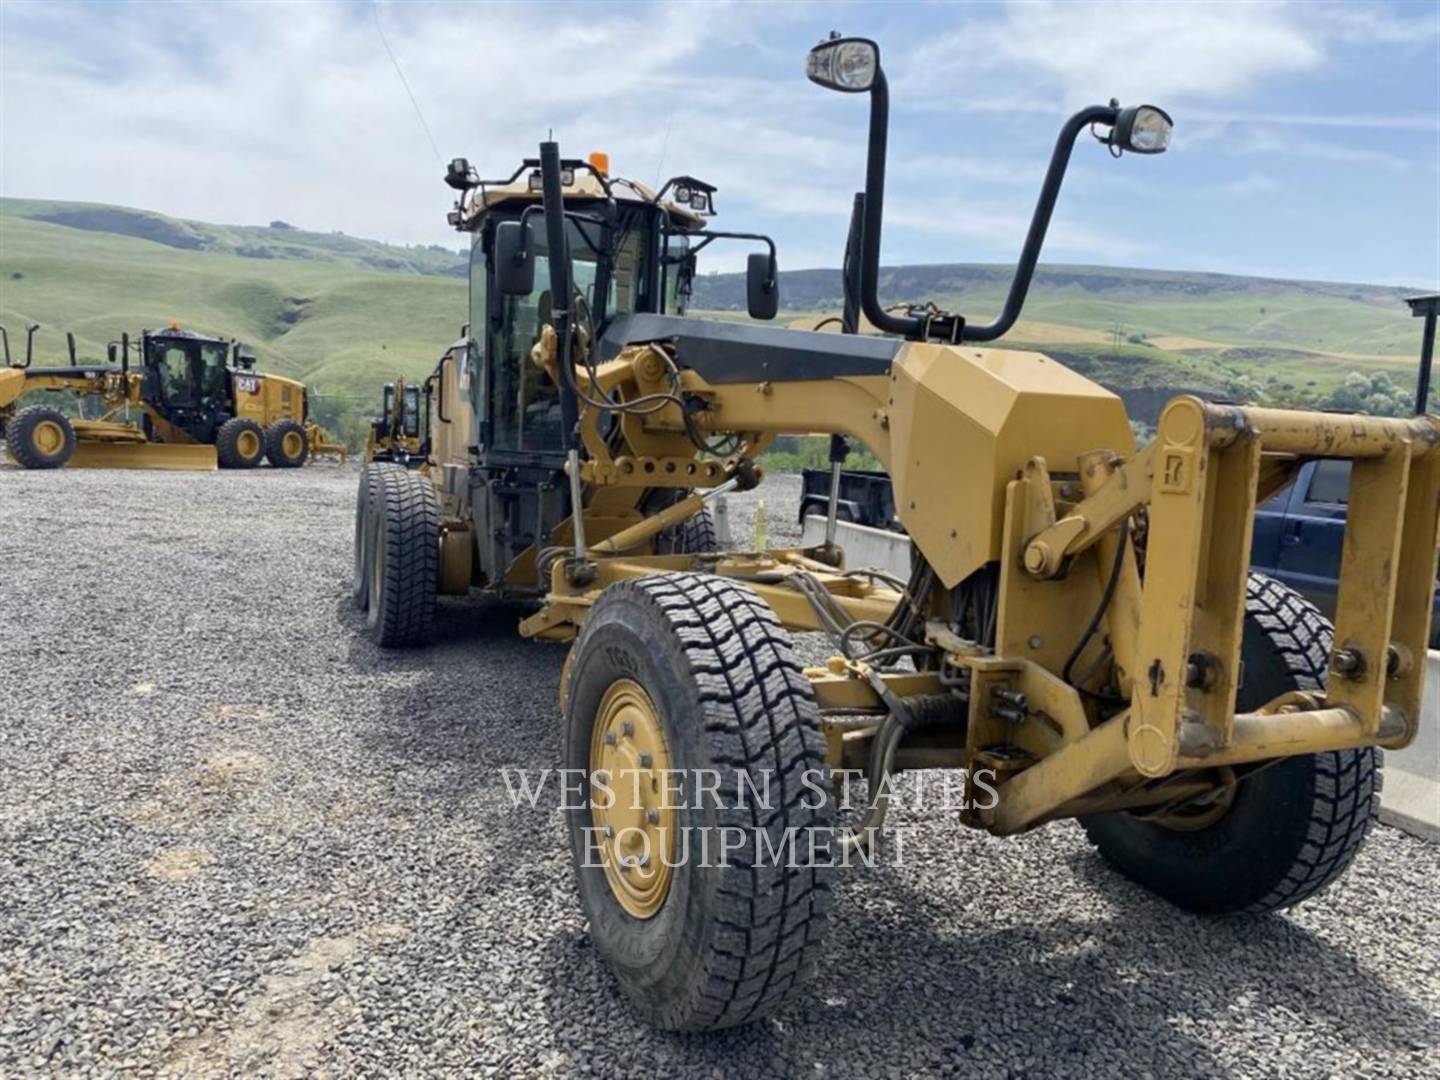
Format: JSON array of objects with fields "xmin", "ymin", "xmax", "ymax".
[{"xmin": 564, "ymin": 573, "xmax": 834, "ymax": 1031}]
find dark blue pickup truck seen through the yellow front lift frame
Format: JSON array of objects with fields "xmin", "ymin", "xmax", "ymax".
[{"xmin": 1250, "ymin": 461, "xmax": 1440, "ymax": 648}]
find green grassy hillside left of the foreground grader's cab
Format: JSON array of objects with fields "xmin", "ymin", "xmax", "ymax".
[{"xmin": 0, "ymin": 215, "xmax": 465, "ymax": 393}]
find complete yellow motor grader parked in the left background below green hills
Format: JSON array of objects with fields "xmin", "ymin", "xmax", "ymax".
[{"xmin": 0, "ymin": 323, "xmax": 346, "ymax": 469}]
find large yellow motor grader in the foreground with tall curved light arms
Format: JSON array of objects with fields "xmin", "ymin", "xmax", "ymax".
[{"xmin": 354, "ymin": 37, "xmax": 1440, "ymax": 1030}]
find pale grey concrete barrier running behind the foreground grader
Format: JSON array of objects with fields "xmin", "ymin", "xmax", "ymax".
[{"xmin": 802, "ymin": 516, "xmax": 1440, "ymax": 841}]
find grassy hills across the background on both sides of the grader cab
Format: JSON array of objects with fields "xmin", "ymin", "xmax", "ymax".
[{"xmin": 0, "ymin": 199, "xmax": 1420, "ymax": 449}]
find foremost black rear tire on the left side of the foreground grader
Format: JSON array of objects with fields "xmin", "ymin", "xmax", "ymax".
[{"xmin": 366, "ymin": 467, "xmax": 441, "ymax": 648}]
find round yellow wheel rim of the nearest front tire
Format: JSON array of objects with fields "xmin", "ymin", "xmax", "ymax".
[{"xmin": 590, "ymin": 678, "xmax": 681, "ymax": 919}]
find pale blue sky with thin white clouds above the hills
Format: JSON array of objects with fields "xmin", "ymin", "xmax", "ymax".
[{"xmin": 0, "ymin": 0, "xmax": 1440, "ymax": 289}]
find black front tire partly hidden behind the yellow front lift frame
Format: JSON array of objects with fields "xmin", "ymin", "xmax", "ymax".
[{"xmin": 1083, "ymin": 573, "xmax": 1381, "ymax": 914}]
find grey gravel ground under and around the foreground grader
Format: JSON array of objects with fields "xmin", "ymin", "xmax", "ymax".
[{"xmin": 0, "ymin": 465, "xmax": 1440, "ymax": 1079}]
